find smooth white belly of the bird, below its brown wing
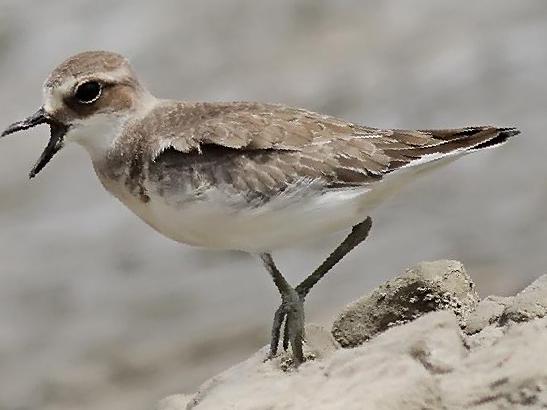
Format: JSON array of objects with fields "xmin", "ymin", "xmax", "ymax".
[{"xmin": 105, "ymin": 176, "xmax": 412, "ymax": 252}]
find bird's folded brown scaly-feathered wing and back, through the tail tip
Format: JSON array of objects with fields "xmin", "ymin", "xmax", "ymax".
[{"xmin": 124, "ymin": 101, "xmax": 518, "ymax": 200}]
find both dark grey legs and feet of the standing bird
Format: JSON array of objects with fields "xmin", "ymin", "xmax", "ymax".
[{"xmin": 260, "ymin": 216, "xmax": 372, "ymax": 366}]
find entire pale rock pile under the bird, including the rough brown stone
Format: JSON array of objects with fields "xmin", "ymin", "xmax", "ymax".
[{"xmin": 156, "ymin": 261, "xmax": 547, "ymax": 410}]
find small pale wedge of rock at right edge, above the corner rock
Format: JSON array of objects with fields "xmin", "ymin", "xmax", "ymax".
[{"xmin": 500, "ymin": 275, "xmax": 547, "ymax": 324}]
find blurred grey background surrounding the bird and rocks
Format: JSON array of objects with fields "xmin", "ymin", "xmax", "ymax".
[{"xmin": 0, "ymin": 0, "xmax": 547, "ymax": 410}]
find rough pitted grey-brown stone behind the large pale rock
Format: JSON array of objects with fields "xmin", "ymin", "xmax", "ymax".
[{"xmin": 332, "ymin": 260, "xmax": 479, "ymax": 347}]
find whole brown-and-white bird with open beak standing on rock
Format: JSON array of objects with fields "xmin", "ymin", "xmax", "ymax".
[{"xmin": 2, "ymin": 51, "xmax": 519, "ymax": 365}]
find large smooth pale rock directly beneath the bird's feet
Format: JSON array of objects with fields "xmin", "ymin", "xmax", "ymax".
[{"xmin": 157, "ymin": 312, "xmax": 465, "ymax": 410}]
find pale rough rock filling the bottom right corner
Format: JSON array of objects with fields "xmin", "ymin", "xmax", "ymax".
[{"xmin": 439, "ymin": 318, "xmax": 547, "ymax": 410}]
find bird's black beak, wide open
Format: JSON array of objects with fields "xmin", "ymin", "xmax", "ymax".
[{"xmin": 0, "ymin": 107, "xmax": 69, "ymax": 178}]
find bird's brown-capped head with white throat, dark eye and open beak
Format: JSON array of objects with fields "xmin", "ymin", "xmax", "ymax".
[{"xmin": 0, "ymin": 51, "xmax": 154, "ymax": 178}]
